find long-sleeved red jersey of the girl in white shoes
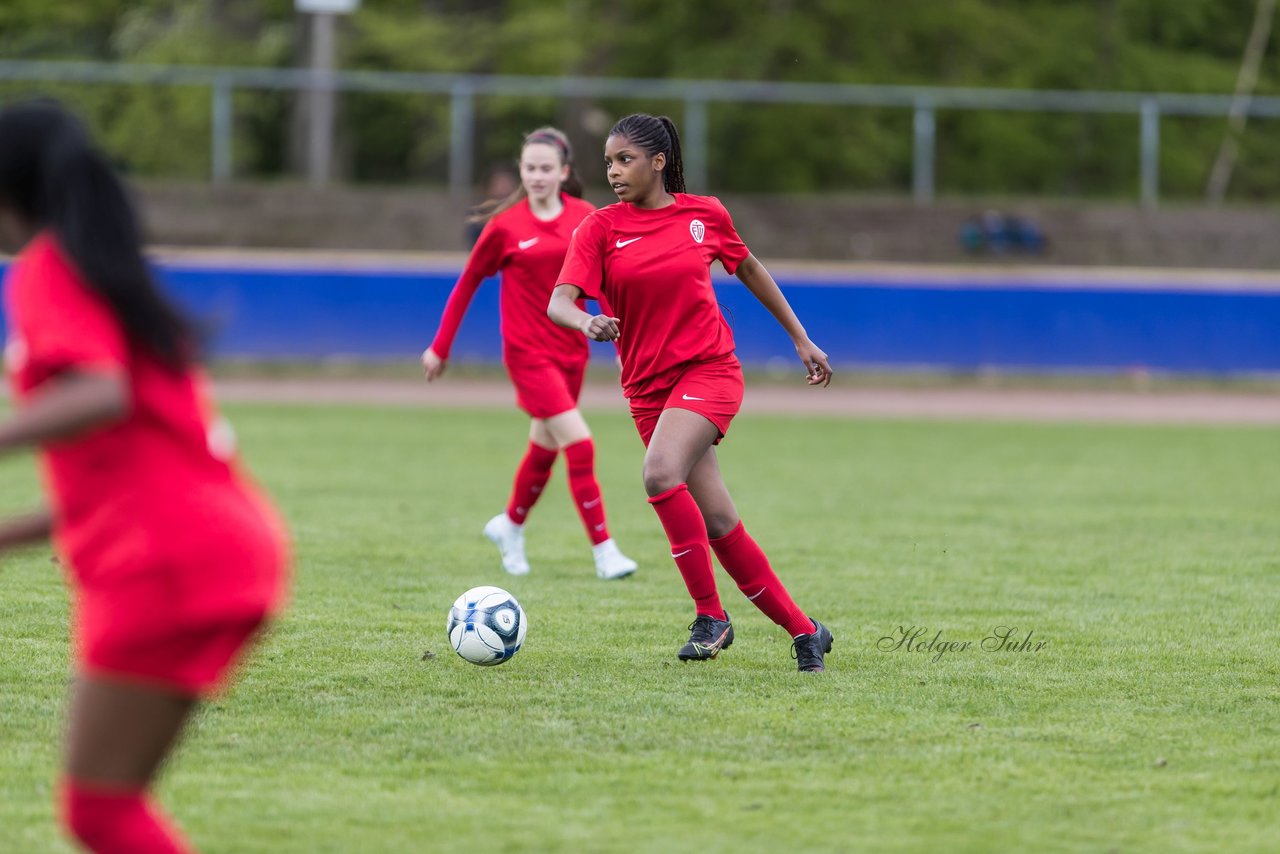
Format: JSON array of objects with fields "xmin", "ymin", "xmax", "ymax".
[{"xmin": 431, "ymin": 193, "xmax": 595, "ymax": 364}]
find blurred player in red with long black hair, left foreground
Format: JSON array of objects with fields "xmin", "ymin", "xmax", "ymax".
[{"xmin": 0, "ymin": 102, "xmax": 287, "ymax": 854}]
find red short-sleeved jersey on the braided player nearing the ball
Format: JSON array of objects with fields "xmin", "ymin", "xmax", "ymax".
[{"xmin": 556, "ymin": 193, "xmax": 750, "ymax": 397}]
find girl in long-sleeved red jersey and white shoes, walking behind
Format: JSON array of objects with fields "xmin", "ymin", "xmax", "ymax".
[{"xmin": 422, "ymin": 128, "xmax": 636, "ymax": 579}]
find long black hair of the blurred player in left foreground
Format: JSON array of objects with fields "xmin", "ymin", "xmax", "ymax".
[{"xmin": 0, "ymin": 100, "xmax": 198, "ymax": 370}]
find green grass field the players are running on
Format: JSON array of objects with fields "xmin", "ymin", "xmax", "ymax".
[{"xmin": 0, "ymin": 406, "xmax": 1280, "ymax": 851}]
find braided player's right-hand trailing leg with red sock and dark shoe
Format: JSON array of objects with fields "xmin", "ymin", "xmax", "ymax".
[{"xmin": 689, "ymin": 448, "xmax": 831, "ymax": 672}]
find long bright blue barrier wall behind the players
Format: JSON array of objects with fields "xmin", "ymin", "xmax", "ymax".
[{"xmin": 2, "ymin": 261, "xmax": 1280, "ymax": 374}]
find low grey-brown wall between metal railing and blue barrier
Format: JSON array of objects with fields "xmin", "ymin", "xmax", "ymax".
[{"xmin": 140, "ymin": 184, "xmax": 1280, "ymax": 269}]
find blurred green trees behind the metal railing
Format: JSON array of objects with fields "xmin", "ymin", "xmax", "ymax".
[{"xmin": 0, "ymin": 0, "xmax": 1280, "ymax": 197}]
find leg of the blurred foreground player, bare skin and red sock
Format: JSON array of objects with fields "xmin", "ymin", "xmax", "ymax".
[{"xmin": 60, "ymin": 676, "xmax": 196, "ymax": 854}]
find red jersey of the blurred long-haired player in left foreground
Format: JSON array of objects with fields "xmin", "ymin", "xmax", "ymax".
[{"xmin": 4, "ymin": 233, "xmax": 284, "ymax": 618}]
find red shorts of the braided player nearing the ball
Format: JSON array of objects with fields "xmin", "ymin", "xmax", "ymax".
[{"xmin": 630, "ymin": 353, "xmax": 745, "ymax": 448}]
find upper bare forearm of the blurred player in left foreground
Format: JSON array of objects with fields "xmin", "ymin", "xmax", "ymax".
[{"xmin": 0, "ymin": 371, "xmax": 129, "ymax": 452}]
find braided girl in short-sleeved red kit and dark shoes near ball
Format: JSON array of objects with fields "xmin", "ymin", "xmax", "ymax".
[{"xmin": 547, "ymin": 114, "xmax": 832, "ymax": 672}]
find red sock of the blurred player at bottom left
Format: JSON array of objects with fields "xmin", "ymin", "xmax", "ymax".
[{"xmin": 60, "ymin": 780, "xmax": 196, "ymax": 854}]
